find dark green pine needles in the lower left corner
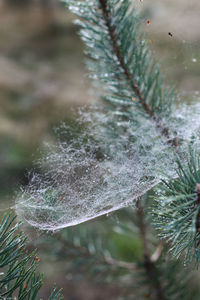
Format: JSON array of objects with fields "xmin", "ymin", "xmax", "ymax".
[{"xmin": 0, "ymin": 215, "xmax": 62, "ymax": 300}]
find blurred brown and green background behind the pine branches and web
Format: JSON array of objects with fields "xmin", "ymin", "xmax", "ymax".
[{"xmin": 0, "ymin": 0, "xmax": 200, "ymax": 300}]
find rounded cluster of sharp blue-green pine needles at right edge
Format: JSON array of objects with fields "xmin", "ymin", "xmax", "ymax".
[{"xmin": 153, "ymin": 150, "xmax": 200, "ymax": 262}]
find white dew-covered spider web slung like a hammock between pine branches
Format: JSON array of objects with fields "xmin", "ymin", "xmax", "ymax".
[{"xmin": 16, "ymin": 101, "xmax": 200, "ymax": 231}]
